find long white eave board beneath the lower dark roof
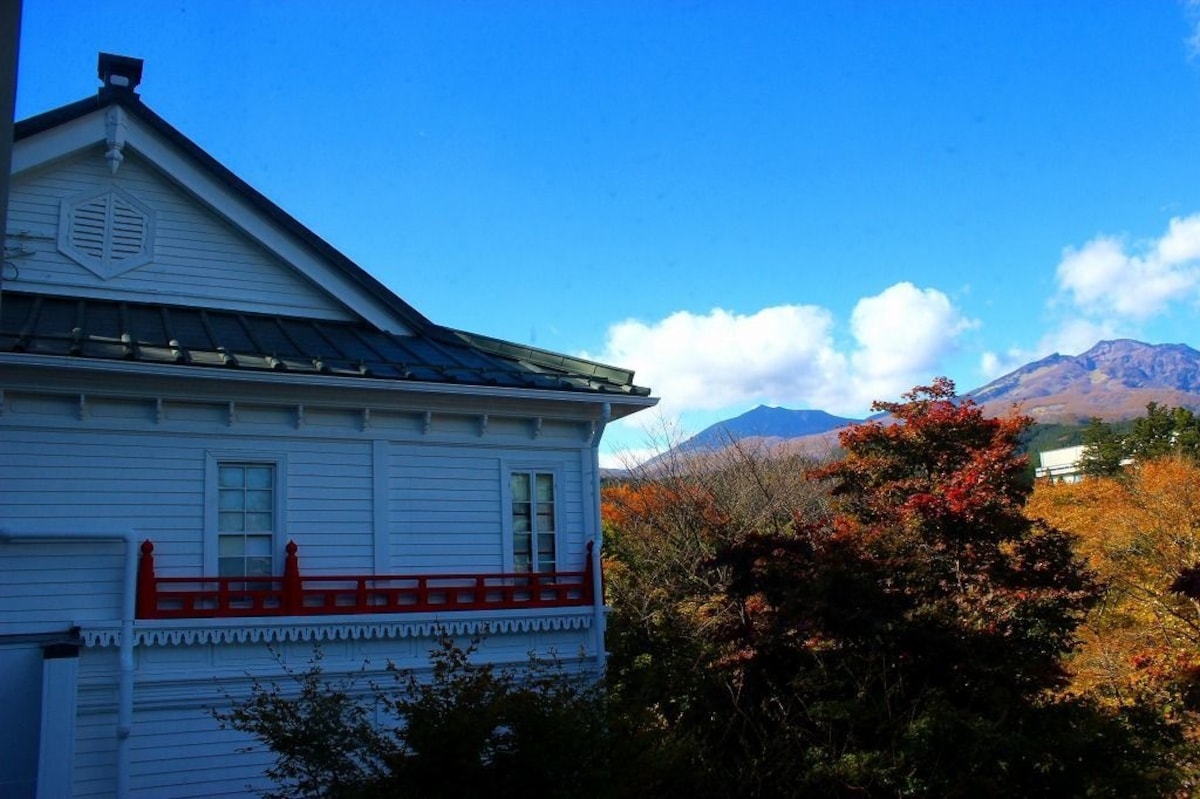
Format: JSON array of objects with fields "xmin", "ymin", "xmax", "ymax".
[{"xmin": 0, "ymin": 353, "xmax": 658, "ymax": 419}]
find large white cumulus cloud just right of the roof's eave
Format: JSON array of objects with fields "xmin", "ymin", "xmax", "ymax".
[{"xmin": 587, "ymin": 283, "xmax": 974, "ymax": 439}]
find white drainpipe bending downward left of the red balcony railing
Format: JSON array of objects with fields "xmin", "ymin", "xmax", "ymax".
[{"xmin": 0, "ymin": 528, "xmax": 138, "ymax": 799}]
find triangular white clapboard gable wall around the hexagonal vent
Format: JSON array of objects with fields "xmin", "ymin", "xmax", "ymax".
[{"xmin": 6, "ymin": 149, "xmax": 353, "ymax": 319}]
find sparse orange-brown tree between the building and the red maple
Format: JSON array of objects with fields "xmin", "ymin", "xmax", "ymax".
[{"xmin": 601, "ymin": 441, "xmax": 828, "ymax": 777}]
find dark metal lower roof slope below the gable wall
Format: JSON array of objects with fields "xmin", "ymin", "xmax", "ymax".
[{"xmin": 0, "ymin": 292, "xmax": 649, "ymax": 397}]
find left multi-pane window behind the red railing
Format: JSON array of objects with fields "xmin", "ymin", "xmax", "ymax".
[{"xmin": 216, "ymin": 461, "xmax": 277, "ymax": 577}]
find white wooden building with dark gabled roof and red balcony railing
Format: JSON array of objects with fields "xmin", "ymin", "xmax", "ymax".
[{"xmin": 0, "ymin": 55, "xmax": 654, "ymax": 798}]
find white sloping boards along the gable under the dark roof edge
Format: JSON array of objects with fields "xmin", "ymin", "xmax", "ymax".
[{"xmin": 12, "ymin": 108, "xmax": 413, "ymax": 335}]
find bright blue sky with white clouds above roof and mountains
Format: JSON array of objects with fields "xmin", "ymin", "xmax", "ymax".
[{"xmin": 17, "ymin": 0, "xmax": 1200, "ymax": 462}]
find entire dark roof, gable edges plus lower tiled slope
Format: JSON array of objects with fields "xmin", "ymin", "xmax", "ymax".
[{"xmin": 0, "ymin": 54, "xmax": 653, "ymax": 404}]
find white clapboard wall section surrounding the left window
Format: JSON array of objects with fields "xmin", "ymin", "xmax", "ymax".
[{"xmin": 0, "ymin": 419, "xmax": 374, "ymax": 576}]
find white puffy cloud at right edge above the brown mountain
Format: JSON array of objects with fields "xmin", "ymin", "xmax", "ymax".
[{"xmin": 1057, "ymin": 214, "xmax": 1200, "ymax": 324}]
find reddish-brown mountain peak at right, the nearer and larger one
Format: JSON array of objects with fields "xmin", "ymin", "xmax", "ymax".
[{"xmin": 970, "ymin": 338, "xmax": 1200, "ymax": 423}]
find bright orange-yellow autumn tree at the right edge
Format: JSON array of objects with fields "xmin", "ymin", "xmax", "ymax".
[{"xmin": 1027, "ymin": 456, "xmax": 1200, "ymax": 789}]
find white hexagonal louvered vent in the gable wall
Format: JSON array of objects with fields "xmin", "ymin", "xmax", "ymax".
[{"xmin": 59, "ymin": 186, "xmax": 154, "ymax": 280}]
